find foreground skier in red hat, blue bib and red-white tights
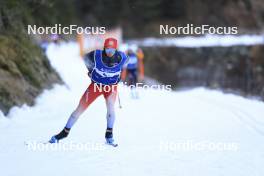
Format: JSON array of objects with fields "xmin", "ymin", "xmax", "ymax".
[{"xmin": 49, "ymin": 38, "xmax": 128, "ymax": 146}]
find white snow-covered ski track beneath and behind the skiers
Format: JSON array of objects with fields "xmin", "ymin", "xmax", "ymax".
[{"xmin": 0, "ymin": 43, "xmax": 264, "ymax": 176}]
